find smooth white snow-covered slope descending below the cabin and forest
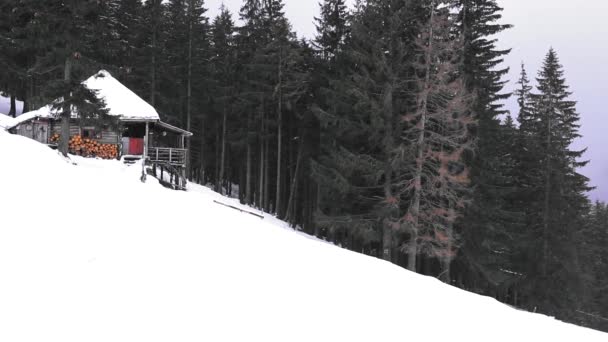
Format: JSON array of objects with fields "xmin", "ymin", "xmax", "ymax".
[{"xmin": 0, "ymin": 130, "xmax": 608, "ymax": 342}]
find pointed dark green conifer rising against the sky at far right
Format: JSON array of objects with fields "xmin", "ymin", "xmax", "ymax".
[{"xmin": 532, "ymin": 49, "xmax": 591, "ymax": 313}]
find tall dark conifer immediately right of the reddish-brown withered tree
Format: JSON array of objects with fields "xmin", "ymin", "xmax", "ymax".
[{"xmin": 457, "ymin": 0, "xmax": 512, "ymax": 294}]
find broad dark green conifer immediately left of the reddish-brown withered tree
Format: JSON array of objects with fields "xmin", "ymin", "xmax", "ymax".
[{"xmin": 316, "ymin": 1, "xmax": 414, "ymax": 261}]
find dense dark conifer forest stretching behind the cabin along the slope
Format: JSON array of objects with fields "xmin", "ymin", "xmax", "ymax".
[{"xmin": 0, "ymin": 0, "xmax": 608, "ymax": 330}]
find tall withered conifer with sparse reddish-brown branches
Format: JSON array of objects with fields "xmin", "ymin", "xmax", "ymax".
[{"xmin": 398, "ymin": 1, "xmax": 475, "ymax": 276}]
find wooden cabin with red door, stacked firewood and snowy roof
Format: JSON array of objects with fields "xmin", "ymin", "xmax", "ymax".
[{"xmin": 8, "ymin": 70, "xmax": 192, "ymax": 189}]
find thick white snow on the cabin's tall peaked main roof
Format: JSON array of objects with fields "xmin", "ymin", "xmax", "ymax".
[{"xmin": 84, "ymin": 70, "xmax": 160, "ymax": 120}]
